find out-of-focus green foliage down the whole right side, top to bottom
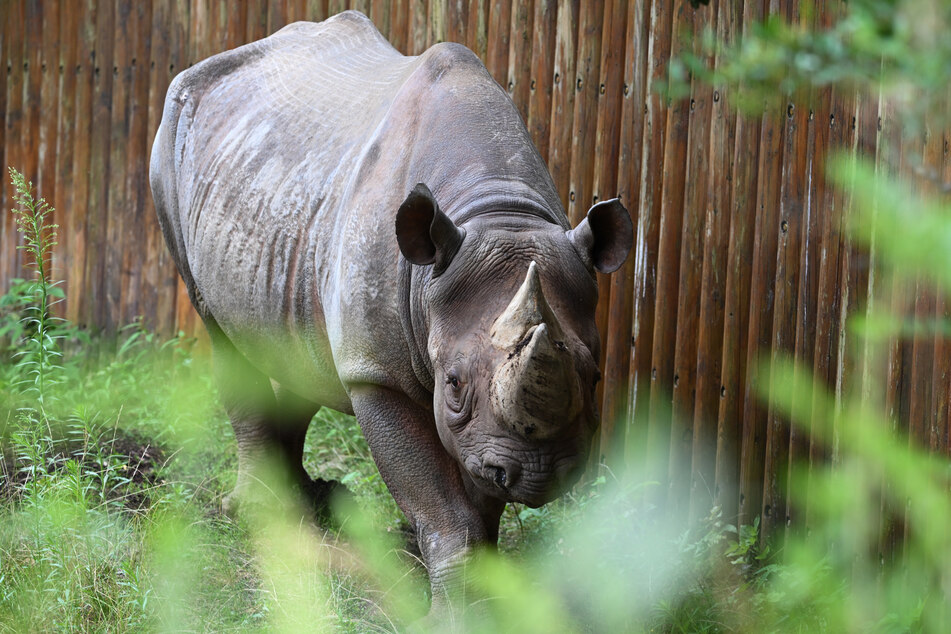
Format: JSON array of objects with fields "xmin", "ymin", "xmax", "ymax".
[{"xmin": 669, "ymin": 0, "xmax": 951, "ymax": 632}]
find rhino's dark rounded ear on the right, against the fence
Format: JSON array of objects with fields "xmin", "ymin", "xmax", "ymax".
[{"xmin": 567, "ymin": 198, "xmax": 634, "ymax": 273}]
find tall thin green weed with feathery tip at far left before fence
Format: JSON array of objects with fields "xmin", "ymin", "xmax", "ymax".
[{"xmin": 10, "ymin": 167, "xmax": 63, "ymax": 410}]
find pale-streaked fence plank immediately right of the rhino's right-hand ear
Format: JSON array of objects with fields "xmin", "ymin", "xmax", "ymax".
[{"xmin": 626, "ymin": 2, "xmax": 673, "ymax": 479}]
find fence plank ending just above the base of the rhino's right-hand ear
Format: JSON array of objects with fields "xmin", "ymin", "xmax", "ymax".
[{"xmin": 567, "ymin": 0, "xmax": 604, "ymax": 226}]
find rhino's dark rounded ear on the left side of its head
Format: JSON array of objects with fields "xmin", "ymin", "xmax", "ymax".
[{"xmin": 396, "ymin": 183, "xmax": 466, "ymax": 276}]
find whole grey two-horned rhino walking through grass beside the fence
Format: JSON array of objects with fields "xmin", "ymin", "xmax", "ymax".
[{"xmin": 150, "ymin": 12, "xmax": 632, "ymax": 608}]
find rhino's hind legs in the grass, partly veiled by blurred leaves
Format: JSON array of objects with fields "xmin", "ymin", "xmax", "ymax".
[{"xmin": 208, "ymin": 327, "xmax": 348, "ymax": 525}]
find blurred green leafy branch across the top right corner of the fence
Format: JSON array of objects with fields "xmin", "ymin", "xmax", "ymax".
[{"xmin": 668, "ymin": 0, "xmax": 951, "ymax": 133}]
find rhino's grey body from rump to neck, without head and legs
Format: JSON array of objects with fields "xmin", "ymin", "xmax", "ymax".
[{"xmin": 151, "ymin": 12, "xmax": 567, "ymax": 404}]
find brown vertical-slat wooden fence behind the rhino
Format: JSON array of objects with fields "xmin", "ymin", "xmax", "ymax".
[{"xmin": 0, "ymin": 0, "xmax": 951, "ymax": 538}]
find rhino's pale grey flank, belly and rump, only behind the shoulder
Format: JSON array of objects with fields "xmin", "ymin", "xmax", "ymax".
[{"xmin": 152, "ymin": 13, "xmax": 424, "ymax": 402}]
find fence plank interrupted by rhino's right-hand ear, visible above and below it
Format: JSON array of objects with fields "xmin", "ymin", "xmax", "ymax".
[{"xmin": 601, "ymin": 2, "xmax": 650, "ymax": 464}]
